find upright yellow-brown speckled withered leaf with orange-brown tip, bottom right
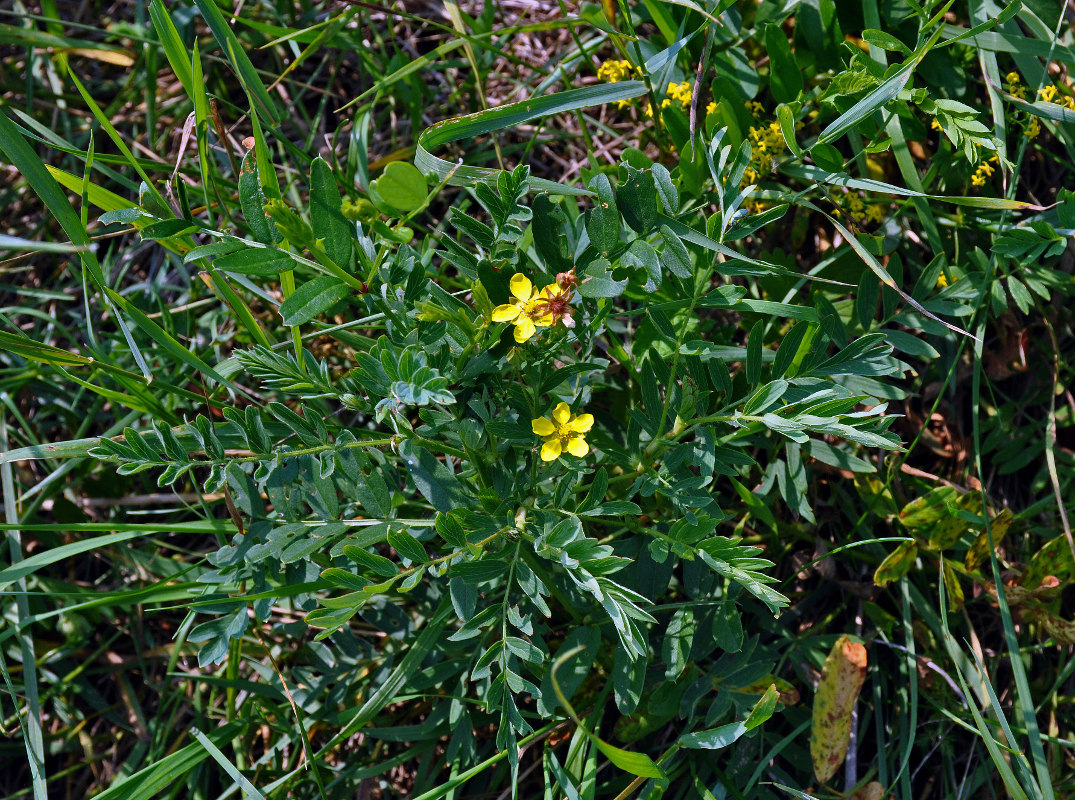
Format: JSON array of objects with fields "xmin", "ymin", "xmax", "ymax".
[{"xmin": 809, "ymin": 637, "xmax": 866, "ymax": 783}]
